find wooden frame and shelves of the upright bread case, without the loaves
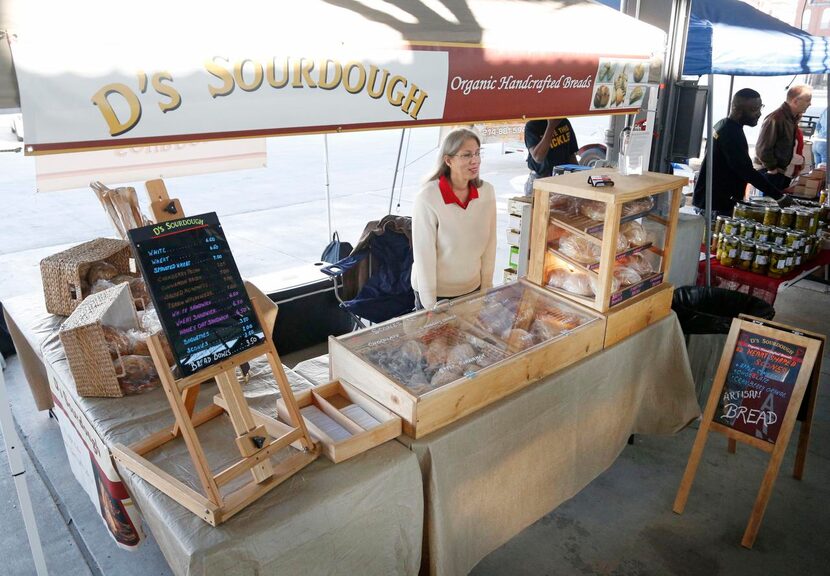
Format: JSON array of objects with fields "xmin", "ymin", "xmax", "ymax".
[{"xmin": 528, "ymin": 168, "xmax": 688, "ymax": 316}]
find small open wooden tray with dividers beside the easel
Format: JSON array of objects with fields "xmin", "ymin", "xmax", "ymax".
[{"xmin": 277, "ymin": 380, "xmax": 401, "ymax": 464}]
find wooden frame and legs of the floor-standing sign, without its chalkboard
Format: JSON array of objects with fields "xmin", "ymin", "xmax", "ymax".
[{"xmin": 672, "ymin": 314, "xmax": 825, "ymax": 548}]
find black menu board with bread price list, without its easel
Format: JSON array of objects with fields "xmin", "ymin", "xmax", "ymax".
[{"xmin": 129, "ymin": 212, "xmax": 265, "ymax": 376}]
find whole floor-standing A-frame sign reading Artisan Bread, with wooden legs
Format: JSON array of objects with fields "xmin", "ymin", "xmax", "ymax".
[{"xmin": 673, "ymin": 315, "xmax": 825, "ymax": 548}]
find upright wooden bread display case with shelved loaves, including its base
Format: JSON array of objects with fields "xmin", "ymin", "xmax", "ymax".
[{"xmin": 528, "ymin": 168, "xmax": 688, "ymax": 346}]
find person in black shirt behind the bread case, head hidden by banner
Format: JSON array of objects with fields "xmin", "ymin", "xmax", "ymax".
[{"xmin": 525, "ymin": 118, "xmax": 579, "ymax": 195}]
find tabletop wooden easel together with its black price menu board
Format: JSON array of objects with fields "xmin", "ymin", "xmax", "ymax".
[{"xmin": 112, "ymin": 213, "xmax": 319, "ymax": 526}]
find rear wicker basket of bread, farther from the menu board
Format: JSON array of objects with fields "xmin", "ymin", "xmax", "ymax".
[{"xmin": 40, "ymin": 238, "xmax": 131, "ymax": 316}]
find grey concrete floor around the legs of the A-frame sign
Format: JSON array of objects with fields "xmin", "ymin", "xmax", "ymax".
[{"xmin": 472, "ymin": 282, "xmax": 830, "ymax": 576}]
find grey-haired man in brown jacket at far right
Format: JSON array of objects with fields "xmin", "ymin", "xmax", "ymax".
[{"xmin": 755, "ymin": 85, "xmax": 813, "ymax": 188}]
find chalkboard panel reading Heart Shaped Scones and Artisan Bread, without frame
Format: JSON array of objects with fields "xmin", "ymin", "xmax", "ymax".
[{"xmin": 714, "ymin": 330, "xmax": 806, "ymax": 444}]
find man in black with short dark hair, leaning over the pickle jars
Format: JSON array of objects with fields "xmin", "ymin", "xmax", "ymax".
[{"xmin": 692, "ymin": 88, "xmax": 783, "ymax": 218}]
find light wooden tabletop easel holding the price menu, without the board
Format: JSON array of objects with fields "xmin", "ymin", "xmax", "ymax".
[{"xmin": 112, "ymin": 285, "xmax": 320, "ymax": 526}]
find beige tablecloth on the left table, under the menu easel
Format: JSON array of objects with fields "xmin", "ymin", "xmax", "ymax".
[{"xmin": 4, "ymin": 295, "xmax": 423, "ymax": 576}]
